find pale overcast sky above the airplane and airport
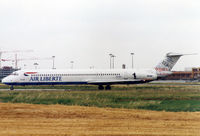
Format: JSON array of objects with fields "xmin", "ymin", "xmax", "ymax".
[{"xmin": 0, "ymin": 0, "xmax": 200, "ymax": 70}]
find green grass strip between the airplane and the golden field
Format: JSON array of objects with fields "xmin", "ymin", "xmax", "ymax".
[{"xmin": 0, "ymin": 84, "xmax": 200, "ymax": 112}]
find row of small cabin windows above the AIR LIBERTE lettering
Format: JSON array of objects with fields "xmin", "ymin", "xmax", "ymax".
[{"xmin": 31, "ymin": 73, "xmax": 120, "ymax": 76}]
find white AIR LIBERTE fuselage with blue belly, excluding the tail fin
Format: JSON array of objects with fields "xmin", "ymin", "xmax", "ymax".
[{"xmin": 2, "ymin": 69, "xmax": 157, "ymax": 85}]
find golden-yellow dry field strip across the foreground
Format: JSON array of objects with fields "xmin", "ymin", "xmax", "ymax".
[{"xmin": 0, "ymin": 103, "xmax": 200, "ymax": 136}]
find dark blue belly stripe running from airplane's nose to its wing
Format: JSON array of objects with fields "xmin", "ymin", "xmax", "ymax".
[{"xmin": 4, "ymin": 82, "xmax": 88, "ymax": 85}]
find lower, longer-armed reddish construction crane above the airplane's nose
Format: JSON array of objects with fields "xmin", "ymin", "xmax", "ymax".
[{"xmin": 1, "ymin": 57, "xmax": 53, "ymax": 69}]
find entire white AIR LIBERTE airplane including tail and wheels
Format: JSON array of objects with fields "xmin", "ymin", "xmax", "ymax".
[{"xmin": 2, "ymin": 52, "xmax": 188, "ymax": 90}]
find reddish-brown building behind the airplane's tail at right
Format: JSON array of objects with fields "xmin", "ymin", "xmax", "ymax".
[{"xmin": 162, "ymin": 68, "xmax": 200, "ymax": 81}]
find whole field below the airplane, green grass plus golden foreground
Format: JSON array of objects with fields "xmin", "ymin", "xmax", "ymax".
[{"xmin": 0, "ymin": 84, "xmax": 200, "ymax": 136}]
